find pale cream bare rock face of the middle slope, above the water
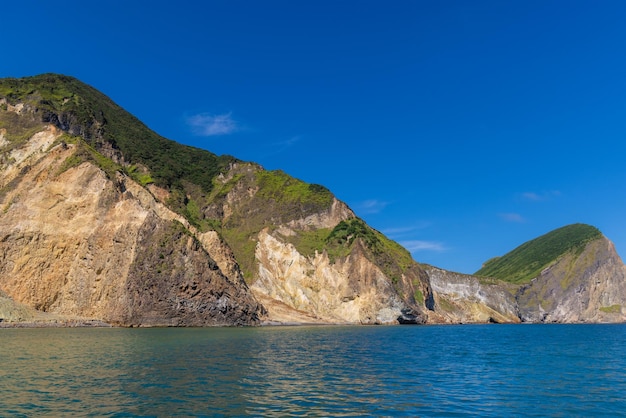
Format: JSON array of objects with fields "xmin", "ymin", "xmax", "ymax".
[{"xmin": 251, "ymin": 230, "xmax": 406, "ymax": 324}]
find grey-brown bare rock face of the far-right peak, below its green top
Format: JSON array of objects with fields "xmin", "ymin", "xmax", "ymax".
[{"xmin": 517, "ymin": 237, "xmax": 626, "ymax": 322}]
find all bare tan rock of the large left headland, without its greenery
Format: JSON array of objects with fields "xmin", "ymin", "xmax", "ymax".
[{"xmin": 0, "ymin": 125, "xmax": 425, "ymax": 326}]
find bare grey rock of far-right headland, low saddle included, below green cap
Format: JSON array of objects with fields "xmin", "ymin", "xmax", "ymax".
[{"xmin": 426, "ymin": 237, "xmax": 626, "ymax": 323}]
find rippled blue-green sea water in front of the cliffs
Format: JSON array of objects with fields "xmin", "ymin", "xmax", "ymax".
[{"xmin": 0, "ymin": 325, "xmax": 626, "ymax": 417}]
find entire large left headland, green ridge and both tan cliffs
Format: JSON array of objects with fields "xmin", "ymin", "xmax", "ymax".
[{"xmin": 0, "ymin": 74, "xmax": 432, "ymax": 325}]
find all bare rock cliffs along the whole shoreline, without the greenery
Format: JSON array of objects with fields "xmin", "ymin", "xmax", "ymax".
[{"xmin": 0, "ymin": 124, "xmax": 626, "ymax": 326}]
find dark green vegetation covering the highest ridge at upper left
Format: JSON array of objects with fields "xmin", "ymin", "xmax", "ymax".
[{"xmin": 0, "ymin": 74, "xmax": 236, "ymax": 191}]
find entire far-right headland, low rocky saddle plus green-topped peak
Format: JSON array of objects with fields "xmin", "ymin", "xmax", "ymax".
[{"xmin": 425, "ymin": 224, "xmax": 626, "ymax": 323}]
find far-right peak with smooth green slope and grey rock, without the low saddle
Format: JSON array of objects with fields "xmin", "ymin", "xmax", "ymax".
[{"xmin": 476, "ymin": 224, "xmax": 626, "ymax": 322}]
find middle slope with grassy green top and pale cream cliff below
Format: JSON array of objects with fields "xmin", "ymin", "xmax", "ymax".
[{"xmin": 197, "ymin": 164, "xmax": 431, "ymax": 324}]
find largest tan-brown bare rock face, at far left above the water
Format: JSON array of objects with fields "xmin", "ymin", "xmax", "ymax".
[{"xmin": 0, "ymin": 127, "xmax": 262, "ymax": 326}]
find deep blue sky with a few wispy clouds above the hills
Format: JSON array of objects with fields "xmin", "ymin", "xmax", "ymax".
[{"xmin": 0, "ymin": 0, "xmax": 626, "ymax": 273}]
